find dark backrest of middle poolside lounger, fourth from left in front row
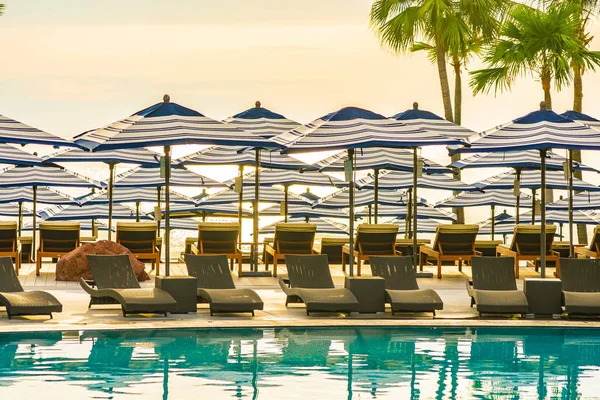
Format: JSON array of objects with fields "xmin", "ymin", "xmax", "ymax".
[{"xmin": 285, "ymin": 254, "xmax": 335, "ymax": 289}]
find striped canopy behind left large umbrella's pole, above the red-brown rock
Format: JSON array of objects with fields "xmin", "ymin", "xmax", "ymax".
[{"xmin": 115, "ymin": 167, "xmax": 225, "ymax": 189}]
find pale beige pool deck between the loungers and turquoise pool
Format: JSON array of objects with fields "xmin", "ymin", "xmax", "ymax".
[{"xmin": 0, "ymin": 263, "xmax": 600, "ymax": 332}]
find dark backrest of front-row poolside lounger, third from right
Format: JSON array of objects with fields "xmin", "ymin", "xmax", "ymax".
[{"xmin": 369, "ymin": 256, "xmax": 419, "ymax": 290}]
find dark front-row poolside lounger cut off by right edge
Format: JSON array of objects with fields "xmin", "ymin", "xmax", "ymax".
[{"xmin": 560, "ymin": 258, "xmax": 600, "ymax": 316}]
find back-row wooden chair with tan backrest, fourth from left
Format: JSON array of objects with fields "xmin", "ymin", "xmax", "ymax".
[{"xmin": 191, "ymin": 222, "xmax": 242, "ymax": 276}]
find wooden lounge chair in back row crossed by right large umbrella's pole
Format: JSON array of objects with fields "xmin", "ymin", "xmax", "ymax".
[{"xmin": 496, "ymin": 225, "xmax": 560, "ymax": 278}]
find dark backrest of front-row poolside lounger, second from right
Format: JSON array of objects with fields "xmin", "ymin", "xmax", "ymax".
[{"xmin": 471, "ymin": 257, "xmax": 517, "ymax": 290}]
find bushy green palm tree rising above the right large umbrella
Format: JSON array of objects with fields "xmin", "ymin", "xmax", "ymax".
[{"xmin": 470, "ymin": 3, "xmax": 600, "ymax": 108}]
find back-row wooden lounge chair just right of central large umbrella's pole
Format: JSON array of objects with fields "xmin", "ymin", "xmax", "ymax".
[{"xmin": 342, "ymin": 224, "xmax": 402, "ymax": 276}]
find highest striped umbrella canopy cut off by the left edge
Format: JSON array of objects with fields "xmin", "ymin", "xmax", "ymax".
[{"xmin": 0, "ymin": 115, "xmax": 80, "ymax": 147}]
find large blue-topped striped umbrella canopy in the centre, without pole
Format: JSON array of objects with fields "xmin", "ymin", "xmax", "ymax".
[{"xmin": 271, "ymin": 107, "xmax": 461, "ymax": 153}]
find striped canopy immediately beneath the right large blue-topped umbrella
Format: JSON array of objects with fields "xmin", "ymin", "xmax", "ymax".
[{"xmin": 450, "ymin": 150, "xmax": 596, "ymax": 171}]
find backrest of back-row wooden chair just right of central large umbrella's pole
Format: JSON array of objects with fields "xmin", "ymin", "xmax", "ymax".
[{"xmin": 354, "ymin": 224, "xmax": 399, "ymax": 255}]
